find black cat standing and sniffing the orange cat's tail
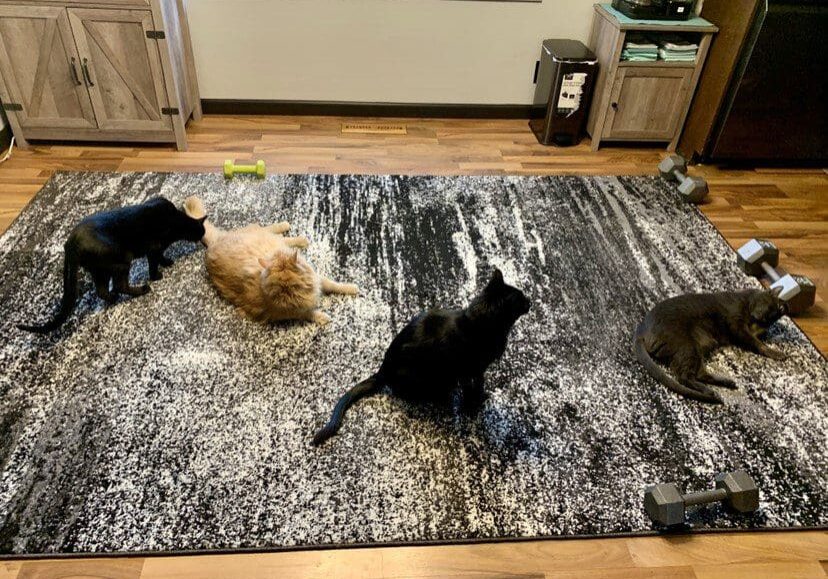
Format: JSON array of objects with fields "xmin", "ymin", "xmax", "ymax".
[{"xmin": 17, "ymin": 197, "xmax": 206, "ymax": 334}]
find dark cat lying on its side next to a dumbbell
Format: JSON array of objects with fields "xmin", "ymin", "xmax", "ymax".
[{"xmin": 634, "ymin": 290, "xmax": 787, "ymax": 403}]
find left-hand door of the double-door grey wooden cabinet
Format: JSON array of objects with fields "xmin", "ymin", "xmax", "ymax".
[{"xmin": 0, "ymin": 6, "xmax": 97, "ymax": 128}]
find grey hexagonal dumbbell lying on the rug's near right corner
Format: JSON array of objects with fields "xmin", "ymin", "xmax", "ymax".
[{"xmin": 644, "ymin": 470, "xmax": 759, "ymax": 527}]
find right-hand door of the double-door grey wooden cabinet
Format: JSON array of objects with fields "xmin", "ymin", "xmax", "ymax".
[{"xmin": 69, "ymin": 8, "xmax": 172, "ymax": 130}]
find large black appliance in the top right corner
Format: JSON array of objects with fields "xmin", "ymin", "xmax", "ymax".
[{"xmin": 700, "ymin": 0, "xmax": 828, "ymax": 163}]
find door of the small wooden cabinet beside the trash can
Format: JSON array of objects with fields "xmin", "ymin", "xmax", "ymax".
[{"xmin": 604, "ymin": 66, "xmax": 693, "ymax": 141}]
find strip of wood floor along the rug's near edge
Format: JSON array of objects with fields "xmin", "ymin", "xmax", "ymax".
[{"xmin": 0, "ymin": 531, "xmax": 828, "ymax": 579}]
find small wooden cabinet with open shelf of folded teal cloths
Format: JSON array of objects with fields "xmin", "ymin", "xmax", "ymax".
[{"xmin": 587, "ymin": 4, "xmax": 718, "ymax": 151}]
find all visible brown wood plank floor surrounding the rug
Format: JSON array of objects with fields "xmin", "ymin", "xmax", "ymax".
[{"xmin": 0, "ymin": 116, "xmax": 828, "ymax": 579}]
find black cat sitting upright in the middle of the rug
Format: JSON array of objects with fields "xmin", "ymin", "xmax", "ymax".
[{"xmin": 313, "ymin": 270, "xmax": 529, "ymax": 446}]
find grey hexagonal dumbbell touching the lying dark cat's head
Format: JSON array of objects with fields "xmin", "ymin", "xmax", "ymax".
[{"xmin": 736, "ymin": 239, "xmax": 816, "ymax": 315}]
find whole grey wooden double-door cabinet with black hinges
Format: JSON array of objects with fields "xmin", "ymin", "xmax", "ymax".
[{"xmin": 0, "ymin": 0, "xmax": 201, "ymax": 150}]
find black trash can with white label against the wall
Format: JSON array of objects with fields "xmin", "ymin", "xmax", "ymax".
[{"xmin": 529, "ymin": 40, "xmax": 598, "ymax": 147}]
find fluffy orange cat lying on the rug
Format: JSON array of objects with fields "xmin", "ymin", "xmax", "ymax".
[{"xmin": 184, "ymin": 197, "xmax": 357, "ymax": 325}]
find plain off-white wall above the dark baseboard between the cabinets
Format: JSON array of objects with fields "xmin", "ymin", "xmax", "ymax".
[{"xmin": 187, "ymin": 0, "xmax": 593, "ymax": 104}]
